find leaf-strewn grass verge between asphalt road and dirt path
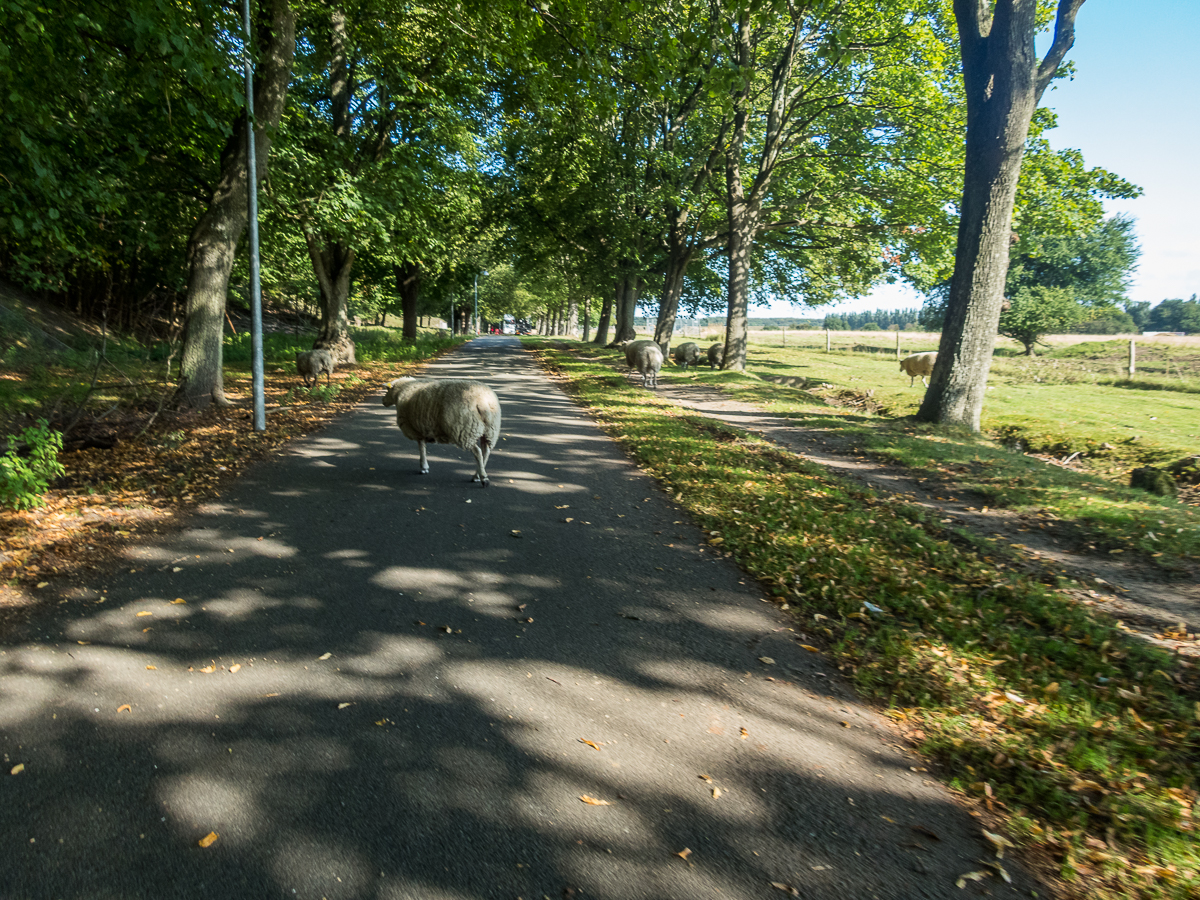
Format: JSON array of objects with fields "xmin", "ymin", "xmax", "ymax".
[{"xmin": 529, "ymin": 342, "xmax": 1200, "ymax": 898}]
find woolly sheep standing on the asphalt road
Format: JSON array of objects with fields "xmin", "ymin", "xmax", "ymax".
[{"xmin": 383, "ymin": 377, "xmax": 500, "ymax": 487}]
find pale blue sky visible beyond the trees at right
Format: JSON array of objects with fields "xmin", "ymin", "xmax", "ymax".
[{"xmin": 768, "ymin": 0, "xmax": 1200, "ymax": 316}]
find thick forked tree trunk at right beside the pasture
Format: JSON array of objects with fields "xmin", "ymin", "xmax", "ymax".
[{"xmin": 917, "ymin": 0, "xmax": 1084, "ymax": 431}]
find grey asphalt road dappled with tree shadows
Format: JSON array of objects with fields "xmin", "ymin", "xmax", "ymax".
[{"xmin": 0, "ymin": 337, "xmax": 1046, "ymax": 900}]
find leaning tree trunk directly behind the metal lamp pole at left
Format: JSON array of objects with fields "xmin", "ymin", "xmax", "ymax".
[{"xmin": 175, "ymin": 0, "xmax": 296, "ymax": 409}]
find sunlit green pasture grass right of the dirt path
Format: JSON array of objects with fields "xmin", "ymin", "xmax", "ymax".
[{"xmin": 648, "ymin": 343, "xmax": 1200, "ymax": 564}]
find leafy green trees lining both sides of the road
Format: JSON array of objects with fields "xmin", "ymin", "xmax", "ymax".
[{"xmin": 0, "ymin": 0, "xmax": 1136, "ymax": 428}]
